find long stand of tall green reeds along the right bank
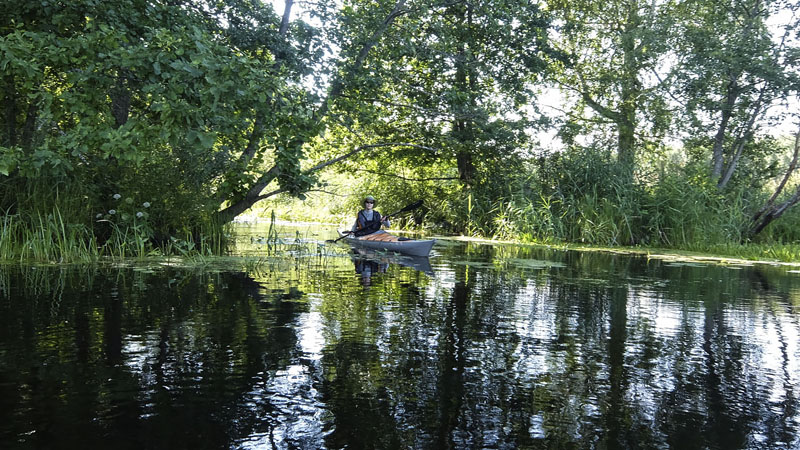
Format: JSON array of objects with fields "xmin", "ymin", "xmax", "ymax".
[{"xmin": 418, "ymin": 146, "xmax": 800, "ymax": 261}]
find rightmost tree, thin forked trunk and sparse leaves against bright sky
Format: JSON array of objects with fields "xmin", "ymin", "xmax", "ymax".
[{"xmin": 675, "ymin": 0, "xmax": 800, "ymax": 189}]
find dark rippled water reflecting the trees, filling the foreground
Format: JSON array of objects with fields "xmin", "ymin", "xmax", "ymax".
[{"xmin": 0, "ymin": 230, "xmax": 800, "ymax": 449}]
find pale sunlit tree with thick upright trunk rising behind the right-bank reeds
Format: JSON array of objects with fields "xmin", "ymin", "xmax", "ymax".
[{"xmin": 548, "ymin": 0, "xmax": 671, "ymax": 176}]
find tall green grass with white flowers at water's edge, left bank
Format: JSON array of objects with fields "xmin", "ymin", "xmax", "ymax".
[{"xmin": 0, "ymin": 180, "xmax": 227, "ymax": 263}]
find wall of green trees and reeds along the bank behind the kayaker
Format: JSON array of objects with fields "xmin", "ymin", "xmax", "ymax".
[{"xmin": 0, "ymin": 0, "xmax": 800, "ymax": 260}]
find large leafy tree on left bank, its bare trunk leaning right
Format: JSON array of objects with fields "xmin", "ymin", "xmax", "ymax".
[{"xmin": 0, "ymin": 0, "xmax": 418, "ymax": 232}]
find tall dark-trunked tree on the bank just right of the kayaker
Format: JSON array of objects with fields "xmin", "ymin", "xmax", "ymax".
[{"xmin": 318, "ymin": 1, "xmax": 550, "ymax": 197}]
